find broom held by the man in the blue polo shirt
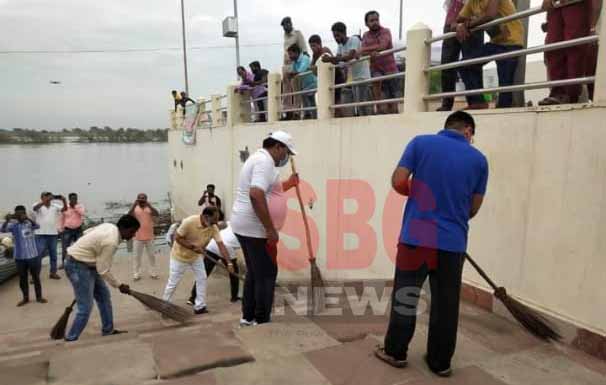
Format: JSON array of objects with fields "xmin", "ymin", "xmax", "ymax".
[{"xmin": 465, "ymin": 253, "xmax": 562, "ymax": 341}]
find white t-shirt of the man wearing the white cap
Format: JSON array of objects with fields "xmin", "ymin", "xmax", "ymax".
[{"xmin": 231, "ymin": 149, "xmax": 279, "ymax": 238}]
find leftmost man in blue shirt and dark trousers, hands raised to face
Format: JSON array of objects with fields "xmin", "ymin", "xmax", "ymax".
[{"xmin": 0, "ymin": 206, "xmax": 47, "ymax": 306}]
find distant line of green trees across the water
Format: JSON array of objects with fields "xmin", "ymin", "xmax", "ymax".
[{"xmin": 0, "ymin": 126, "xmax": 168, "ymax": 144}]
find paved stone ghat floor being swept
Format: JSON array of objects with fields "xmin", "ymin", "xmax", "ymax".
[{"xmin": 0, "ymin": 244, "xmax": 606, "ymax": 385}]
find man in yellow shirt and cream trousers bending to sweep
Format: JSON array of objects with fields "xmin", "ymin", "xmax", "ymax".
[{"xmin": 164, "ymin": 206, "xmax": 234, "ymax": 314}]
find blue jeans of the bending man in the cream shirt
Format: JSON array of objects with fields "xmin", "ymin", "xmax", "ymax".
[{"xmin": 65, "ymin": 257, "xmax": 114, "ymax": 341}]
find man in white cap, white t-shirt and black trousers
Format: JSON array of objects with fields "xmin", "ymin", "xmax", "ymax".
[{"xmin": 231, "ymin": 131, "xmax": 298, "ymax": 326}]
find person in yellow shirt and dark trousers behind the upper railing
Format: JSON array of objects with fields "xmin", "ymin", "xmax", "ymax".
[{"xmin": 456, "ymin": 0, "xmax": 524, "ymax": 109}]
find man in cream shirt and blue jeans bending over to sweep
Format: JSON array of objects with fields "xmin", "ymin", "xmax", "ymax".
[{"xmin": 65, "ymin": 215, "xmax": 139, "ymax": 341}]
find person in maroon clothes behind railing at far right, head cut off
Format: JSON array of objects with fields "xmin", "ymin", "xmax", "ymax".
[{"xmin": 539, "ymin": 0, "xmax": 601, "ymax": 106}]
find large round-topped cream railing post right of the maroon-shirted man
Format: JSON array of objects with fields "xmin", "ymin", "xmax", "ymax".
[{"xmin": 404, "ymin": 23, "xmax": 431, "ymax": 113}]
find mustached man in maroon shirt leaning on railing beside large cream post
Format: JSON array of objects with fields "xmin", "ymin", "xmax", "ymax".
[{"xmin": 360, "ymin": 11, "xmax": 401, "ymax": 114}]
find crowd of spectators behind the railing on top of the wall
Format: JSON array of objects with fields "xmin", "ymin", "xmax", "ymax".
[{"xmin": 179, "ymin": 0, "xmax": 602, "ymax": 118}]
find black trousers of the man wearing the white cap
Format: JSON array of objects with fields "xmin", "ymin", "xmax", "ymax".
[{"xmin": 236, "ymin": 234, "xmax": 278, "ymax": 324}]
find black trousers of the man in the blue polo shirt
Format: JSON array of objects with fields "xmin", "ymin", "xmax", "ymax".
[{"xmin": 385, "ymin": 245, "xmax": 464, "ymax": 370}]
